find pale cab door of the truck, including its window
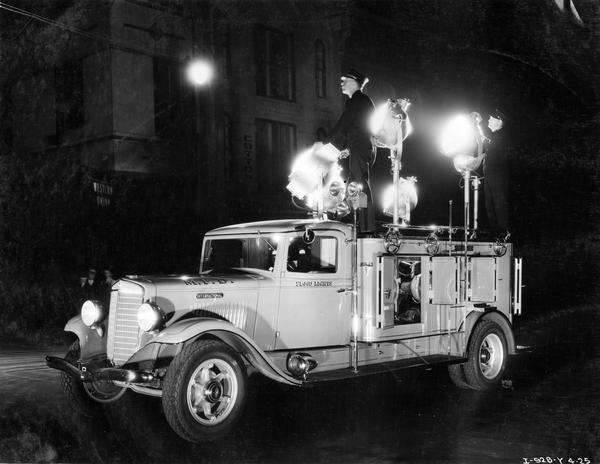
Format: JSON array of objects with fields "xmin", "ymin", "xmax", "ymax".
[{"xmin": 275, "ymin": 231, "xmax": 351, "ymax": 349}]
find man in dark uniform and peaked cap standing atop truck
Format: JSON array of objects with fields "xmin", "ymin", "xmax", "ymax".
[{"xmin": 323, "ymin": 69, "xmax": 375, "ymax": 232}]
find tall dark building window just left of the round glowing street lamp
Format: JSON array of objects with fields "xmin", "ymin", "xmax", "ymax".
[{"xmin": 153, "ymin": 57, "xmax": 183, "ymax": 138}]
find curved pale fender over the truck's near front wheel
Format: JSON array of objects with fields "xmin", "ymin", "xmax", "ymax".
[{"xmin": 140, "ymin": 317, "xmax": 302, "ymax": 386}]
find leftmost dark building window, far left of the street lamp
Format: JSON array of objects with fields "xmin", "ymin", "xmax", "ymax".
[{"xmin": 54, "ymin": 60, "xmax": 84, "ymax": 134}]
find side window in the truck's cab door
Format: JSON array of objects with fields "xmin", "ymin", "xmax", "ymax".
[{"xmin": 287, "ymin": 237, "xmax": 337, "ymax": 274}]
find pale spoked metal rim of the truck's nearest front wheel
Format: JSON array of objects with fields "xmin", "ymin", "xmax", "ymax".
[{"xmin": 187, "ymin": 359, "xmax": 238, "ymax": 425}]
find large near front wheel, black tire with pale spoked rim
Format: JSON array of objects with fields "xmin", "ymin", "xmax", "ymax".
[{"xmin": 162, "ymin": 340, "xmax": 246, "ymax": 443}]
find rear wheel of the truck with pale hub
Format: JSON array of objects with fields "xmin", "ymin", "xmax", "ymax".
[{"xmin": 463, "ymin": 321, "xmax": 507, "ymax": 390}]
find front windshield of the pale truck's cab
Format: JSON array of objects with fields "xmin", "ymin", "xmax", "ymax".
[{"xmin": 200, "ymin": 236, "xmax": 277, "ymax": 273}]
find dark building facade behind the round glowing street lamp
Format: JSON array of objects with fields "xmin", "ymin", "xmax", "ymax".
[{"xmin": 9, "ymin": 0, "xmax": 344, "ymax": 222}]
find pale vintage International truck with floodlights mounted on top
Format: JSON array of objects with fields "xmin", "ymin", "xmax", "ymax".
[{"xmin": 46, "ymin": 102, "xmax": 522, "ymax": 442}]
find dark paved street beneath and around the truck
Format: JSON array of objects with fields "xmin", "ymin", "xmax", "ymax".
[{"xmin": 0, "ymin": 309, "xmax": 600, "ymax": 464}]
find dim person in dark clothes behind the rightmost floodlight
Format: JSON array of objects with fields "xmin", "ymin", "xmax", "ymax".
[{"xmin": 483, "ymin": 110, "xmax": 510, "ymax": 240}]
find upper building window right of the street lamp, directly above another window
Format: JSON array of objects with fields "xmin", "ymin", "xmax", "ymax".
[{"xmin": 255, "ymin": 27, "xmax": 296, "ymax": 101}]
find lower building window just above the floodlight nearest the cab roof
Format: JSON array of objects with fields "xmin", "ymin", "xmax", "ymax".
[{"xmin": 256, "ymin": 119, "xmax": 296, "ymax": 192}]
